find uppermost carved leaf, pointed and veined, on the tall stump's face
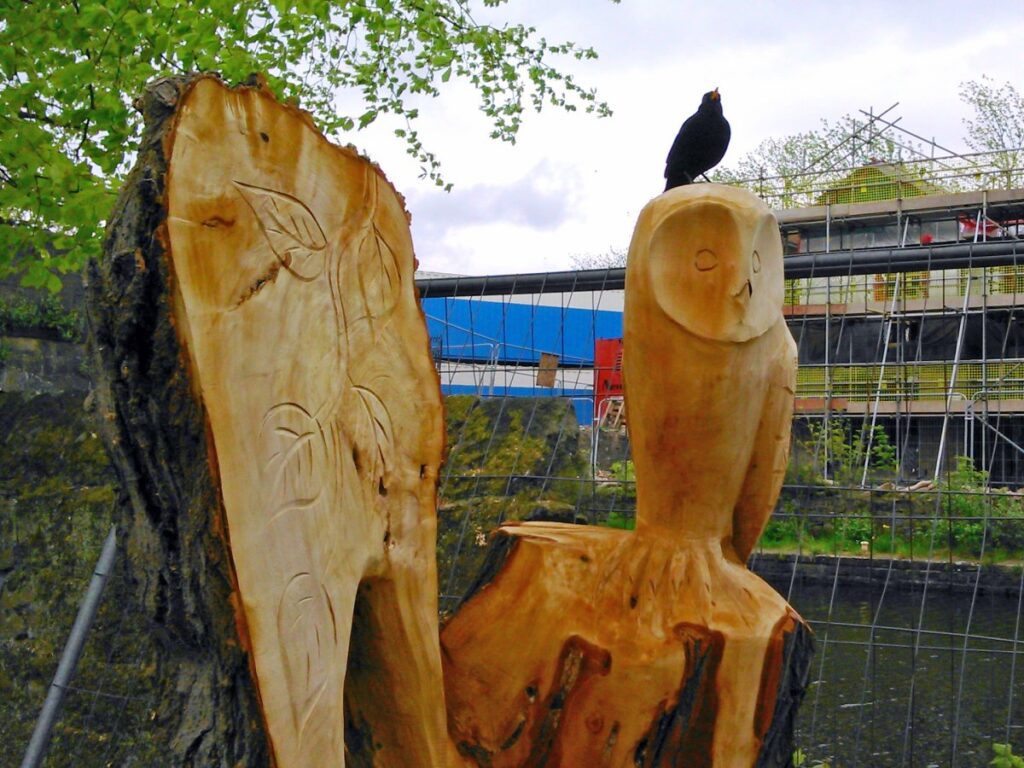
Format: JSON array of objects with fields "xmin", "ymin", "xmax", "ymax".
[{"xmin": 233, "ymin": 181, "xmax": 327, "ymax": 283}]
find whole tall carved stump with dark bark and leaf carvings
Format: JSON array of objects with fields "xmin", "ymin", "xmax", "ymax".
[{"xmin": 89, "ymin": 76, "xmax": 458, "ymax": 767}]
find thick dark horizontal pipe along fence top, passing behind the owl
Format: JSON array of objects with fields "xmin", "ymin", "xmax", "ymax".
[{"xmin": 416, "ymin": 241, "xmax": 1024, "ymax": 299}]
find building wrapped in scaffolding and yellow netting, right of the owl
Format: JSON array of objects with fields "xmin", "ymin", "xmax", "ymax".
[{"xmin": 738, "ymin": 104, "xmax": 1024, "ymax": 484}]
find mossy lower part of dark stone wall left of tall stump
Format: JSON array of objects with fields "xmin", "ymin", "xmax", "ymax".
[{"xmin": 0, "ymin": 392, "xmax": 160, "ymax": 766}]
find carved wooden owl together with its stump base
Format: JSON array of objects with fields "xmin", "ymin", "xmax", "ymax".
[{"xmin": 441, "ymin": 184, "xmax": 812, "ymax": 768}]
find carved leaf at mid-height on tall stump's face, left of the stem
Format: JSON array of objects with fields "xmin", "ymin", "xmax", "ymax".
[{"xmin": 260, "ymin": 402, "xmax": 328, "ymax": 520}]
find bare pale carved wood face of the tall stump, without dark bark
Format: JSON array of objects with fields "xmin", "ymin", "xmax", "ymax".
[{"xmin": 93, "ymin": 77, "xmax": 458, "ymax": 767}]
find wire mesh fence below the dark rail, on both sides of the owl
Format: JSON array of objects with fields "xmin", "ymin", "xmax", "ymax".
[{"xmin": 425, "ymin": 249, "xmax": 1024, "ymax": 766}]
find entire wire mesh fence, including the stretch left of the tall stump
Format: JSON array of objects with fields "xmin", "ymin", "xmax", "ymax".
[{"xmin": 6, "ymin": 237, "xmax": 1024, "ymax": 768}]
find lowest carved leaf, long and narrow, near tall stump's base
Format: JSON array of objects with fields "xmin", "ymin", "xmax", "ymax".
[{"xmin": 278, "ymin": 572, "xmax": 338, "ymax": 737}]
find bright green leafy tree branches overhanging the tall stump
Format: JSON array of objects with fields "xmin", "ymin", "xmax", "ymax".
[{"xmin": 0, "ymin": 0, "xmax": 607, "ymax": 289}]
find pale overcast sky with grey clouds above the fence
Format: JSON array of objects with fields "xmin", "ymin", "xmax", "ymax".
[{"xmin": 346, "ymin": 0, "xmax": 1024, "ymax": 274}]
